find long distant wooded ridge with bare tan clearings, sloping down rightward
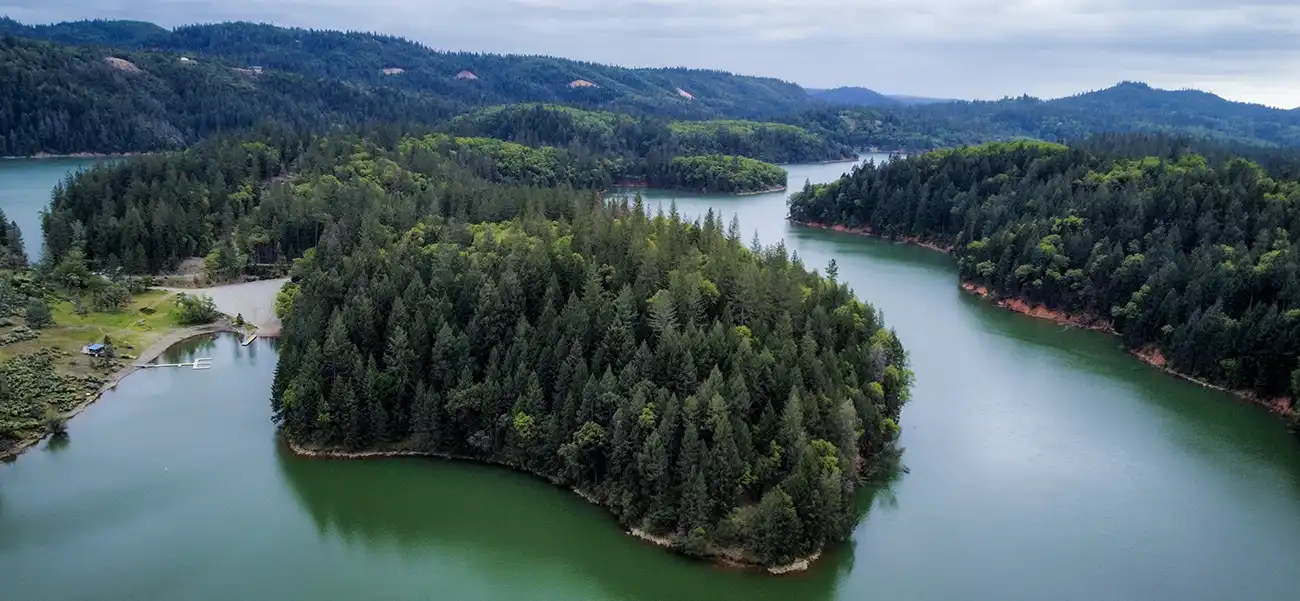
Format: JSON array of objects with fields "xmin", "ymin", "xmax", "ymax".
[{"xmin": 0, "ymin": 20, "xmax": 816, "ymax": 118}]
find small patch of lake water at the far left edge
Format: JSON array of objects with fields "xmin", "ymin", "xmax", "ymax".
[{"xmin": 0, "ymin": 157, "xmax": 104, "ymax": 263}]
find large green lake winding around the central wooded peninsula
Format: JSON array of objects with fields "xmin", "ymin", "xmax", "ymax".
[{"xmin": 0, "ymin": 158, "xmax": 1300, "ymax": 601}]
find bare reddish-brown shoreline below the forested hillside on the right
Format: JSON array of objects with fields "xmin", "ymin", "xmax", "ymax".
[{"xmin": 789, "ymin": 220, "xmax": 1296, "ymax": 419}]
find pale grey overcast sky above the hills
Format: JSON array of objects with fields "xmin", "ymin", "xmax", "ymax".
[{"xmin": 10, "ymin": 0, "xmax": 1300, "ymax": 108}]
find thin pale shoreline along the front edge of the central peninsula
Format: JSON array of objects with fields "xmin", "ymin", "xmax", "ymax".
[{"xmin": 289, "ymin": 433, "xmax": 822, "ymax": 576}]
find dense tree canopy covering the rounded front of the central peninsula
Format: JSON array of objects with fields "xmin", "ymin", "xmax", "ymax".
[{"xmin": 274, "ymin": 187, "xmax": 911, "ymax": 565}]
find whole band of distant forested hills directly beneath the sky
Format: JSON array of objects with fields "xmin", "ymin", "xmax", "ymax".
[{"xmin": 0, "ymin": 18, "xmax": 1300, "ymax": 163}]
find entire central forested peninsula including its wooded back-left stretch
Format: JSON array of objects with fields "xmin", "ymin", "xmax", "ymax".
[{"xmin": 44, "ymin": 130, "xmax": 913, "ymax": 571}]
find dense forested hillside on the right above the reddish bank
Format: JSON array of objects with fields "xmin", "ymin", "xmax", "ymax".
[{"xmin": 790, "ymin": 138, "xmax": 1300, "ymax": 407}]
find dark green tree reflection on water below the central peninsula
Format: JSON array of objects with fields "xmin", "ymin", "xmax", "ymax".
[{"xmin": 276, "ymin": 431, "xmax": 892, "ymax": 600}]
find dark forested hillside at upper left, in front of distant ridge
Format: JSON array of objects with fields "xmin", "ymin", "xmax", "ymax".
[{"xmin": 0, "ymin": 36, "xmax": 452, "ymax": 156}]
